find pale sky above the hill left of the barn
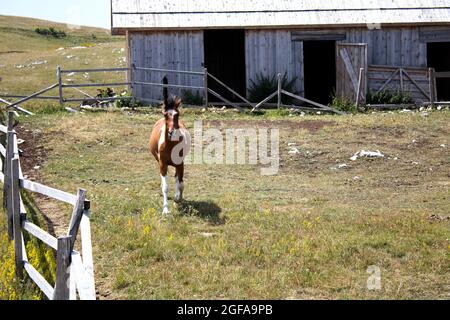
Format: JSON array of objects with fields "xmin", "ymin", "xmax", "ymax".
[{"xmin": 0, "ymin": 0, "xmax": 111, "ymax": 29}]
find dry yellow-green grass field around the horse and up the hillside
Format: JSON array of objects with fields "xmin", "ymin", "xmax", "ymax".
[{"xmin": 0, "ymin": 15, "xmax": 450, "ymax": 299}]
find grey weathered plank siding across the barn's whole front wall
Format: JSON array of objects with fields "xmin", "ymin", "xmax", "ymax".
[{"xmin": 129, "ymin": 26, "xmax": 450, "ymax": 101}]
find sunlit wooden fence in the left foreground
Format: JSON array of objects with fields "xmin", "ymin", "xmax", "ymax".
[{"xmin": 0, "ymin": 112, "xmax": 96, "ymax": 300}]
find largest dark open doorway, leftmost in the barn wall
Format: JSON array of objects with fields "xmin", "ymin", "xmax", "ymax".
[{"xmin": 204, "ymin": 29, "xmax": 246, "ymax": 102}]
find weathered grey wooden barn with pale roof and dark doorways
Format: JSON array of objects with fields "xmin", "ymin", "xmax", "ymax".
[{"xmin": 111, "ymin": 0, "xmax": 450, "ymax": 104}]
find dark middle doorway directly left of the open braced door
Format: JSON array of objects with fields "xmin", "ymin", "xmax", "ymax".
[{"xmin": 303, "ymin": 40, "xmax": 336, "ymax": 104}]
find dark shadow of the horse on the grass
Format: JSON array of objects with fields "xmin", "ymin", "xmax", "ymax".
[{"xmin": 178, "ymin": 200, "xmax": 225, "ymax": 225}]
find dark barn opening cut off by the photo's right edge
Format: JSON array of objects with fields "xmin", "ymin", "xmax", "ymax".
[{"xmin": 427, "ymin": 42, "xmax": 450, "ymax": 101}]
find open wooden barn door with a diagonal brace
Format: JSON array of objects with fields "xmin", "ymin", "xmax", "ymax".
[{"xmin": 336, "ymin": 43, "xmax": 368, "ymax": 103}]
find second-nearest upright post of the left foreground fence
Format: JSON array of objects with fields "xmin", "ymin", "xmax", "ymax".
[{"xmin": 11, "ymin": 156, "xmax": 23, "ymax": 278}]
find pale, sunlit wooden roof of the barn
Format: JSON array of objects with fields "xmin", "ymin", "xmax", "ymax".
[{"xmin": 111, "ymin": 0, "xmax": 450, "ymax": 33}]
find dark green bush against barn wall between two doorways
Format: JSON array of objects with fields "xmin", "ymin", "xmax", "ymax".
[{"xmin": 248, "ymin": 72, "xmax": 297, "ymax": 104}]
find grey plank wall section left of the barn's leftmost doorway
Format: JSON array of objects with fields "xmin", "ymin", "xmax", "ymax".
[{"xmin": 129, "ymin": 31, "xmax": 204, "ymax": 101}]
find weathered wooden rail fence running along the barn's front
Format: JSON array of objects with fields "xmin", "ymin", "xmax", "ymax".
[{"xmin": 0, "ymin": 64, "xmax": 444, "ymax": 115}]
